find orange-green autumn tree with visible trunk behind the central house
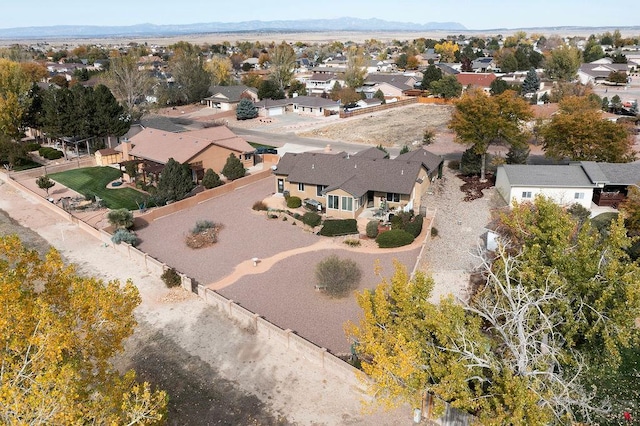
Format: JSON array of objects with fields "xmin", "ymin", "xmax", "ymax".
[{"xmin": 449, "ymin": 89, "xmax": 533, "ymax": 179}]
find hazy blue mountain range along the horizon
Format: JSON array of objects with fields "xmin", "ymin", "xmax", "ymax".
[{"xmin": 0, "ymin": 17, "xmax": 466, "ymax": 39}]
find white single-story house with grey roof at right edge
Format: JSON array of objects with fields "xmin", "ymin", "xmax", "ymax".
[{"xmin": 496, "ymin": 161, "xmax": 640, "ymax": 209}]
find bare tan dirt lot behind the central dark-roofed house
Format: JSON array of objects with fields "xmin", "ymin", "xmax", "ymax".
[{"xmin": 298, "ymin": 104, "xmax": 453, "ymax": 146}]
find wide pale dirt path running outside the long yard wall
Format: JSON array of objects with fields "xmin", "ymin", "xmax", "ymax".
[{"xmin": 0, "ymin": 180, "xmax": 411, "ymax": 425}]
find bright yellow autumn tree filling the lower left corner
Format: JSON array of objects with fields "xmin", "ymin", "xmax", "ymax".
[{"xmin": 0, "ymin": 236, "xmax": 167, "ymax": 424}]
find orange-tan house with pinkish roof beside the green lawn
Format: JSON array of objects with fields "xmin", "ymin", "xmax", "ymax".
[{"xmin": 115, "ymin": 126, "xmax": 255, "ymax": 180}]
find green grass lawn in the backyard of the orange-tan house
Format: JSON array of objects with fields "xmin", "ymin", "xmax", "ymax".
[{"xmin": 49, "ymin": 167, "xmax": 148, "ymax": 210}]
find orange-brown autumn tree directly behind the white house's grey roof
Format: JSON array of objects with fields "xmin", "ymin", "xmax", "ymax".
[{"xmin": 540, "ymin": 96, "xmax": 634, "ymax": 163}]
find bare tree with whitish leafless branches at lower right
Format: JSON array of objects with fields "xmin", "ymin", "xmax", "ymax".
[{"xmin": 443, "ymin": 248, "xmax": 610, "ymax": 420}]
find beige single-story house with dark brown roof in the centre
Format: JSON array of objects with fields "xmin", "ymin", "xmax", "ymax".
[{"xmin": 273, "ymin": 148, "xmax": 443, "ymax": 219}]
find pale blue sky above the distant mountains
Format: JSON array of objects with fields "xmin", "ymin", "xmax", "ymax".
[{"xmin": 0, "ymin": 0, "xmax": 640, "ymax": 29}]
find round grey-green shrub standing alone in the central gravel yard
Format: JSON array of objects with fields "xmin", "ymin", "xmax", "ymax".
[{"xmin": 315, "ymin": 255, "xmax": 362, "ymax": 297}]
